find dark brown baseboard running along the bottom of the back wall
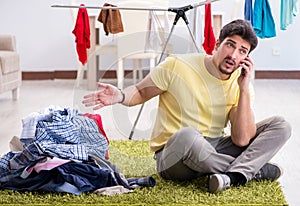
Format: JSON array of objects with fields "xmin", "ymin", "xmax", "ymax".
[{"xmin": 22, "ymin": 70, "xmax": 300, "ymax": 80}]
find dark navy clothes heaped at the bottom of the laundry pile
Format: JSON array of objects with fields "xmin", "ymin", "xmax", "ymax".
[{"xmin": 0, "ymin": 162, "xmax": 117, "ymax": 194}]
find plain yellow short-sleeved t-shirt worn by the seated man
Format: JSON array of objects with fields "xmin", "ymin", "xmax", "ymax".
[{"xmin": 150, "ymin": 53, "xmax": 254, "ymax": 151}]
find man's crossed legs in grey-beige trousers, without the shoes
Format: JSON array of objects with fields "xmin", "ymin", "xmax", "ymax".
[{"xmin": 156, "ymin": 116, "xmax": 291, "ymax": 181}]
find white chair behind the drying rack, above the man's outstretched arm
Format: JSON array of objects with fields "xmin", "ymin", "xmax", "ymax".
[{"xmin": 117, "ymin": 0, "xmax": 165, "ymax": 88}]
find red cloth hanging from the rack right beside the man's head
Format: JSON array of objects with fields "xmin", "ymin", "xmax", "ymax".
[{"xmin": 202, "ymin": 0, "xmax": 216, "ymax": 55}]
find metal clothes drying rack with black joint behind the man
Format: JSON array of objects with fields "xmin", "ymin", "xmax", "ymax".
[{"xmin": 51, "ymin": 0, "xmax": 220, "ymax": 140}]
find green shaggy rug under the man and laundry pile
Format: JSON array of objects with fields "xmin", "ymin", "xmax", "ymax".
[{"xmin": 0, "ymin": 140, "xmax": 287, "ymax": 206}]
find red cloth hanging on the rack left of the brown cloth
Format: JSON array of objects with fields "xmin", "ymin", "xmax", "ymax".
[{"xmin": 72, "ymin": 4, "xmax": 91, "ymax": 65}]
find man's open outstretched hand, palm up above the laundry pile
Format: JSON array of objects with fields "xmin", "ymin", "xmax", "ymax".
[{"xmin": 82, "ymin": 83, "xmax": 123, "ymax": 110}]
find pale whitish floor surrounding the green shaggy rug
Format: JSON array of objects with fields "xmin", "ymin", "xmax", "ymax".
[{"xmin": 0, "ymin": 80, "xmax": 300, "ymax": 206}]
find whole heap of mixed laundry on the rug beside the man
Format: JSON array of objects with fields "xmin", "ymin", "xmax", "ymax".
[{"xmin": 0, "ymin": 106, "xmax": 155, "ymax": 195}]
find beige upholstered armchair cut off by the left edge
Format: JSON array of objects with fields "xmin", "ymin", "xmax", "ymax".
[{"xmin": 0, "ymin": 34, "xmax": 22, "ymax": 100}]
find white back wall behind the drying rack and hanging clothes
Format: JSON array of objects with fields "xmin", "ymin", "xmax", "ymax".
[{"xmin": 0, "ymin": 0, "xmax": 300, "ymax": 71}]
